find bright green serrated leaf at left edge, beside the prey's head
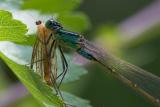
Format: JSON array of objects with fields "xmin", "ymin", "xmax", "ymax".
[{"xmin": 0, "ymin": 10, "xmax": 27, "ymax": 43}]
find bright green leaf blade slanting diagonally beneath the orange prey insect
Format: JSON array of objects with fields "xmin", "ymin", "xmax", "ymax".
[{"xmin": 0, "ymin": 53, "xmax": 63, "ymax": 107}]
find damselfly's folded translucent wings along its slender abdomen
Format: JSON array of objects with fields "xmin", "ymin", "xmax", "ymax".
[{"xmin": 84, "ymin": 40, "xmax": 160, "ymax": 106}]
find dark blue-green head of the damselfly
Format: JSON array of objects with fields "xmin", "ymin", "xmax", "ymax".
[{"xmin": 45, "ymin": 19, "xmax": 63, "ymax": 31}]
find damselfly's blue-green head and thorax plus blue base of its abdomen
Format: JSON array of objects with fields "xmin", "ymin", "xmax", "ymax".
[{"xmin": 45, "ymin": 19, "xmax": 95, "ymax": 60}]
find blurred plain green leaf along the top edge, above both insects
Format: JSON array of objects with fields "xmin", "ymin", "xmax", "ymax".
[{"xmin": 22, "ymin": 0, "xmax": 81, "ymax": 13}]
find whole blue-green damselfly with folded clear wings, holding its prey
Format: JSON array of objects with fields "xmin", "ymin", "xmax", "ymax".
[{"xmin": 45, "ymin": 19, "xmax": 160, "ymax": 106}]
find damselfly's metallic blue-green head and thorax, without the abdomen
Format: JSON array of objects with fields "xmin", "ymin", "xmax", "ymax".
[{"xmin": 45, "ymin": 19, "xmax": 81, "ymax": 49}]
